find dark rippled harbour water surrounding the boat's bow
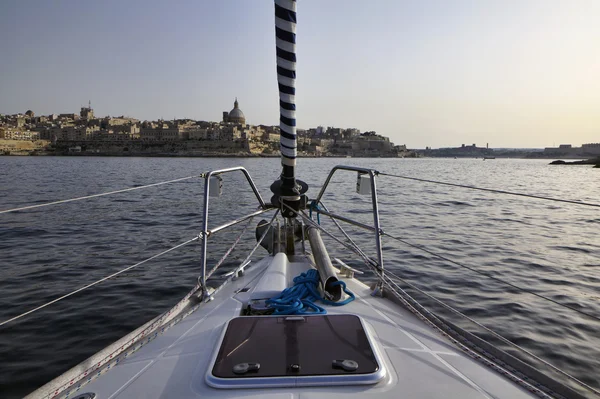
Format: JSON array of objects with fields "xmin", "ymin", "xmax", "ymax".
[{"xmin": 0, "ymin": 157, "xmax": 600, "ymax": 398}]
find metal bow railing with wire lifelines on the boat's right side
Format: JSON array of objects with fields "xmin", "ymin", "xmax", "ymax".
[{"xmin": 299, "ymin": 166, "xmax": 600, "ymax": 398}]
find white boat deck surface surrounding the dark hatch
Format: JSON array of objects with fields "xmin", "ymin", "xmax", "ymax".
[{"xmin": 77, "ymin": 258, "xmax": 535, "ymax": 399}]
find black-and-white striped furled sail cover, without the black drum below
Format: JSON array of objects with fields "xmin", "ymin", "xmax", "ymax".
[{"xmin": 275, "ymin": 0, "xmax": 297, "ymax": 168}]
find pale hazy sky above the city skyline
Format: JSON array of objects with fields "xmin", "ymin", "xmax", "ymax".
[{"xmin": 0, "ymin": 0, "xmax": 600, "ymax": 148}]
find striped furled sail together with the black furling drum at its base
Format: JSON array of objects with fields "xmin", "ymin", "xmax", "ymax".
[{"xmin": 271, "ymin": 0, "xmax": 308, "ymax": 218}]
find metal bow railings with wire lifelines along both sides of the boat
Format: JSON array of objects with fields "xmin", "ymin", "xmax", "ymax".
[{"xmin": 0, "ymin": 166, "xmax": 600, "ymax": 397}]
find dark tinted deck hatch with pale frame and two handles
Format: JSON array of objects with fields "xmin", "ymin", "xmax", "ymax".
[{"xmin": 207, "ymin": 315, "xmax": 385, "ymax": 388}]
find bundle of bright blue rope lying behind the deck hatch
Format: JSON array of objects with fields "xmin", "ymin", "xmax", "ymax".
[{"xmin": 266, "ymin": 269, "xmax": 354, "ymax": 315}]
